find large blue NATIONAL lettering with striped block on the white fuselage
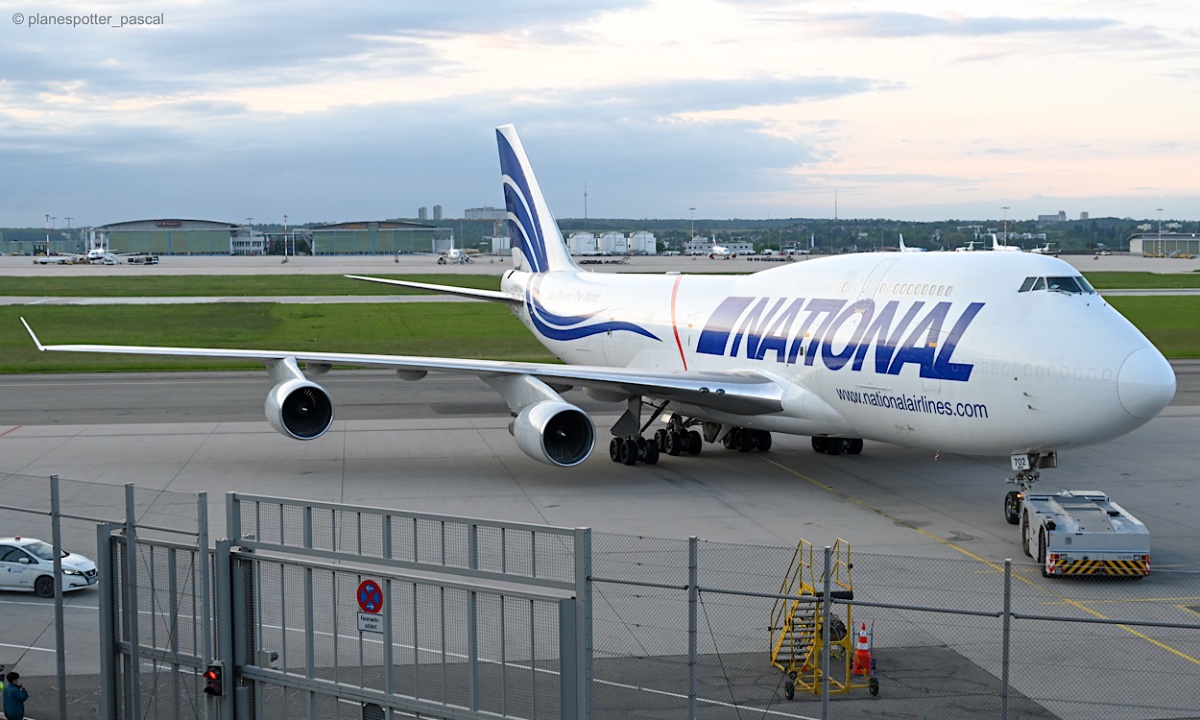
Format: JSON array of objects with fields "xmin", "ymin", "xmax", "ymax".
[{"xmin": 696, "ymin": 296, "xmax": 984, "ymax": 382}]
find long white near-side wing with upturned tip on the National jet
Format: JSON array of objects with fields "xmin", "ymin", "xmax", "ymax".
[{"xmin": 20, "ymin": 316, "xmax": 785, "ymax": 415}]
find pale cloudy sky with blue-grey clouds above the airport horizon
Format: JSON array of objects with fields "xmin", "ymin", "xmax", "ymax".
[{"xmin": 0, "ymin": 0, "xmax": 1200, "ymax": 228}]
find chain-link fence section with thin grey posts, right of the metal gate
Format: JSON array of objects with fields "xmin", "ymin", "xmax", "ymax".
[{"xmin": 593, "ymin": 533, "xmax": 1200, "ymax": 720}]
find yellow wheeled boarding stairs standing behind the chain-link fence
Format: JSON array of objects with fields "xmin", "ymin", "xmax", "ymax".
[{"xmin": 770, "ymin": 538, "xmax": 880, "ymax": 700}]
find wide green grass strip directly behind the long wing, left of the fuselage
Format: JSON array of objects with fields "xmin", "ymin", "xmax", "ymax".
[{"xmin": 0, "ymin": 302, "xmax": 554, "ymax": 373}]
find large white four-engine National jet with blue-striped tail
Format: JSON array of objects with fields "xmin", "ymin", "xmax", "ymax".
[{"xmin": 23, "ymin": 125, "xmax": 1175, "ymax": 521}]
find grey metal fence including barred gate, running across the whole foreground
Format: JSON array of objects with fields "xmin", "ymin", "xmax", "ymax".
[{"xmin": 0, "ymin": 475, "xmax": 1200, "ymax": 720}]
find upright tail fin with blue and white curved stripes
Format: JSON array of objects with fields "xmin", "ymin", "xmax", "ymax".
[{"xmin": 496, "ymin": 125, "xmax": 578, "ymax": 272}]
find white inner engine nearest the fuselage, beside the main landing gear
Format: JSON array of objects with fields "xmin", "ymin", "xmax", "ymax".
[{"xmin": 512, "ymin": 400, "xmax": 596, "ymax": 468}]
